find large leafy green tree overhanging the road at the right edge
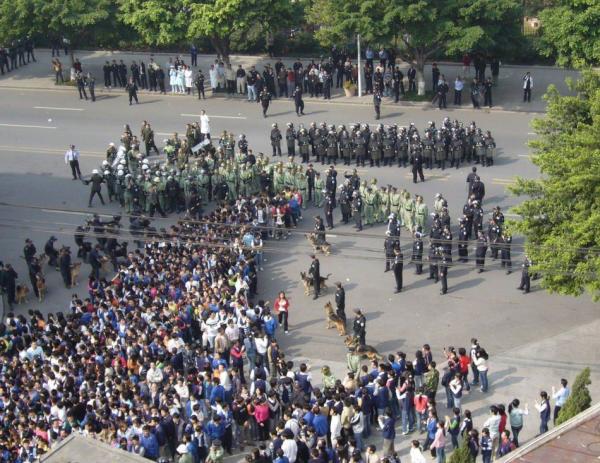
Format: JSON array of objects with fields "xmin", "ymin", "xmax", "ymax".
[{"xmin": 510, "ymin": 70, "xmax": 600, "ymax": 300}]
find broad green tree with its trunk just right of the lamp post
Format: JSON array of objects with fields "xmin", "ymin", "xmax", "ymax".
[{"xmin": 307, "ymin": 0, "xmax": 522, "ymax": 94}]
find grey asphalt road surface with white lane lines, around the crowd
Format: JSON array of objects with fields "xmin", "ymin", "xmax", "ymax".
[{"xmin": 0, "ymin": 62, "xmax": 600, "ymax": 463}]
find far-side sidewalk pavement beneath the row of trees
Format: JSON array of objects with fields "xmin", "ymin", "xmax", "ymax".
[{"xmin": 0, "ymin": 49, "xmax": 579, "ymax": 112}]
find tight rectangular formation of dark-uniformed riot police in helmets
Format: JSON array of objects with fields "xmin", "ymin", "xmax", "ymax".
[{"xmin": 270, "ymin": 117, "xmax": 496, "ymax": 169}]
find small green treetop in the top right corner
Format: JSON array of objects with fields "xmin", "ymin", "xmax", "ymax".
[{"xmin": 538, "ymin": 0, "xmax": 600, "ymax": 67}]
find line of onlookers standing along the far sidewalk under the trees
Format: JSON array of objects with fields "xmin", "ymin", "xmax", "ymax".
[{"xmin": 52, "ymin": 46, "xmax": 510, "ymax": 111}]
